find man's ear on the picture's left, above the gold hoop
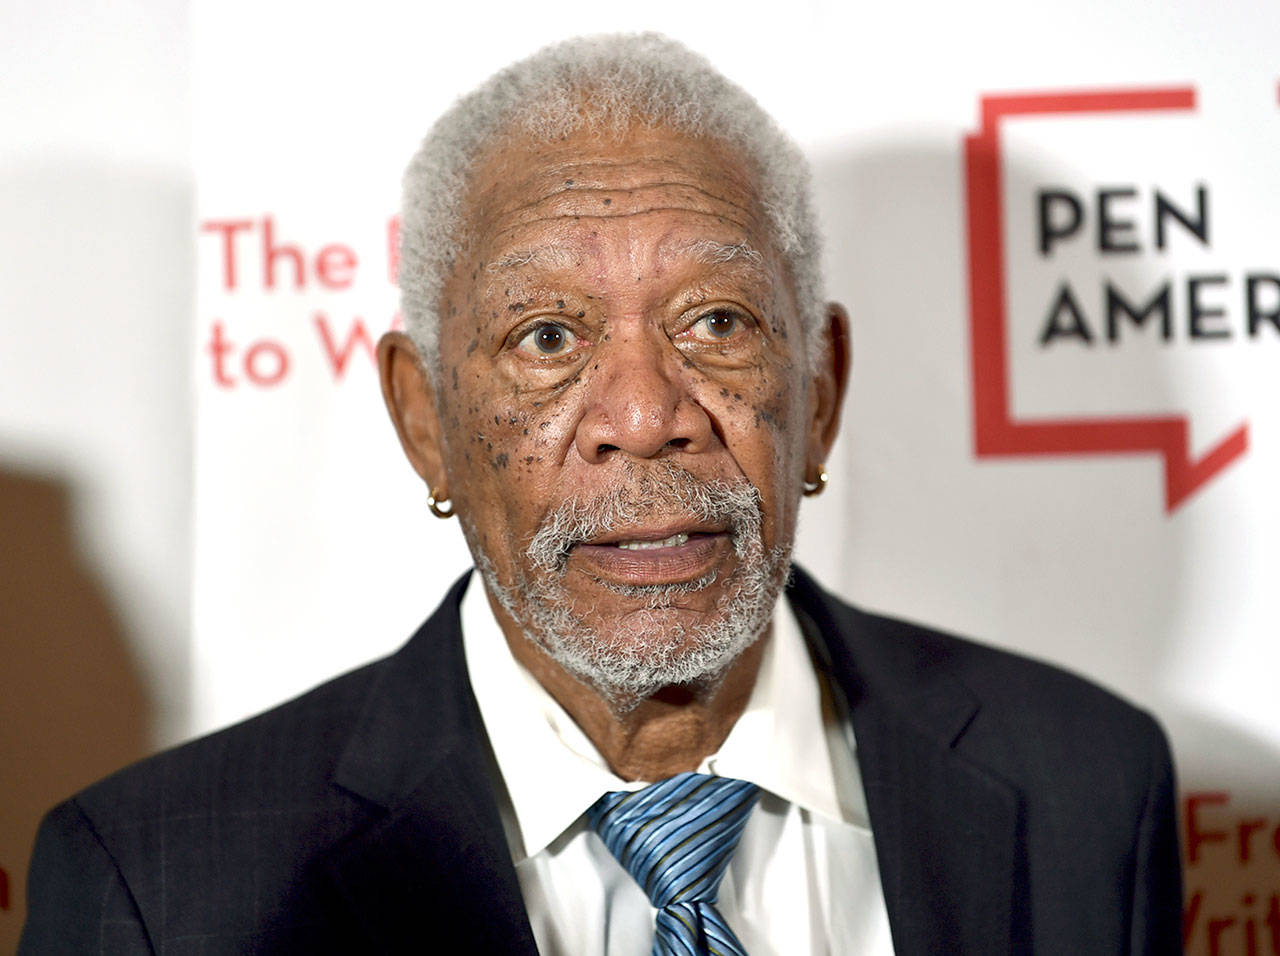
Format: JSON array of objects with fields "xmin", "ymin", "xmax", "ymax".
[{"xmin": 378, "ymin": 331, "xmax": 449, "ymax": 500}]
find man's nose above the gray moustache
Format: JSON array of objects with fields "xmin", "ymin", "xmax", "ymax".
[{"xmin": 575, "ymin": 334, "xmax": 714, "ymax": 463}]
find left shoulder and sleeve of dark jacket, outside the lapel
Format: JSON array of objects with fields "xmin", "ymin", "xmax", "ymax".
[{"xmin": 19, "ymin": 662, "xmax": 384, "ymax": 956}]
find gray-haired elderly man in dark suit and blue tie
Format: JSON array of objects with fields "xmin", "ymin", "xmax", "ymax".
[{"xmin": 23, "ymin": 37, "xmax": 1180, "ymax": 956}]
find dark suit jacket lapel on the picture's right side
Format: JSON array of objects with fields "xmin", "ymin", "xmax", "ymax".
[{"xmin": 791, "ymin": 571, "xmax": 1021, "ymax": 955}]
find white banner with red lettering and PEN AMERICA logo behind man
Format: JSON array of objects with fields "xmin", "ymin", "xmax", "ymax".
[{"xmin": 191, "ymin": 0, "xmax": 1280, "ymax": 956}]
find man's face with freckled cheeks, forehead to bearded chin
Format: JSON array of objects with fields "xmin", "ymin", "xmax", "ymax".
[{"xmin": 404, "ymin": 128, "xmax": 820, "ymax": 691}]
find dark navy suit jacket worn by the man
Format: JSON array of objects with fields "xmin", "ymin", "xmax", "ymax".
[{"xmin": 19, "ymin": 571, "xmax": 1180, "ymax": 956}]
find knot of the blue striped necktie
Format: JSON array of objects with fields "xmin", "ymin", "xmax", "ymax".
[{"xmin": 588, "ymin": 773, "xmax": 760, "ymax": 910}]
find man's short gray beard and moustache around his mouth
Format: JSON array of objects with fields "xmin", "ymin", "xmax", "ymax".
[{"xmin": 468, "ymin": 461, "xmax": 791, "ymax": 709}]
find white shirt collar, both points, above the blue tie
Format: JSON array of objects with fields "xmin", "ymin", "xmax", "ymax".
[{"xmin": 462, "ymin": 573, "xmax": 865, "ymax": 863}]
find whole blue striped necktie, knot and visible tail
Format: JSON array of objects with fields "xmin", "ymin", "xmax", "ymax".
[{"xmin": 586, "ymin": 773, "xmax": 760, "ymax": 956}]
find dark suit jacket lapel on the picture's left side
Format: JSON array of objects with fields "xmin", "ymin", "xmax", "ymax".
[{"xmin": 326, "ymin": 578, "xmax": 536, "ymax": 956}]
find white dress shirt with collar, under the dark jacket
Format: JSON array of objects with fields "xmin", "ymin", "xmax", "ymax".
[{"xmin": 462, "ymin": 575, "xmax": 893, "ymax": 956}]
